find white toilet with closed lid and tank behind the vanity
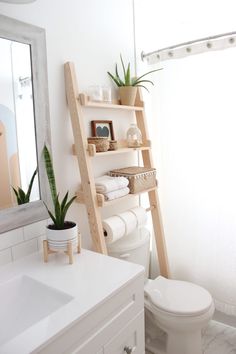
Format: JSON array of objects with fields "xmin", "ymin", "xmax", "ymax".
[{"xmin": 108, "ymin": 227, "xmax": 214, "ymax": 354}]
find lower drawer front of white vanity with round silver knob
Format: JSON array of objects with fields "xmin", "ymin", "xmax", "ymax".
[{"xmin": 104, "ymin": 311, "xmax": 145, "ymax": 354}]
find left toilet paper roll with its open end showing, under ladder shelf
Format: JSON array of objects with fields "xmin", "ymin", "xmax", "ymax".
[{"xmin": 102, "ymin": 215, "xmax": 126, "ymax": 243}]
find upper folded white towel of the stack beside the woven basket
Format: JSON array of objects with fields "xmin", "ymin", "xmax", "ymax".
[{"xmin": 95, "ymin": 175, "xmax": 129, "ymax": 193}]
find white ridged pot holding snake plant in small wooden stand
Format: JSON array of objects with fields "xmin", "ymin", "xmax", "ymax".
[{"xmin": 46, "ymin": 224, "xmax": 78, "ymax": 244}]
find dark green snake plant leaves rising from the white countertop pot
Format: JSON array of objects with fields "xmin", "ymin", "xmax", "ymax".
[{"xmin": 43, "ymin": 145, "xmax": 76, "ymax": 230}]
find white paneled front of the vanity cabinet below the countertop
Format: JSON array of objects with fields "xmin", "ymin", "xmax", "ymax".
[{"xmin": 37, "ymin": 274, "xmax": 145, "ymax": 354}]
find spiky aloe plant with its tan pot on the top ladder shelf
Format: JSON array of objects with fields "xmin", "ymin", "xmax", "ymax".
[{"xmin": 107, "ymin": 55, "xmax": 161, "ymax": 106}]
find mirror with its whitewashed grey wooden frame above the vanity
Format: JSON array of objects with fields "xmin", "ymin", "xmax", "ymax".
[{"xmin": 0, "ymin": 14, "xmax": 50, "ymax": 234}]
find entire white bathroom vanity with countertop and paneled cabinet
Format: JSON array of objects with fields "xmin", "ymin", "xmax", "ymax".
[{"xmin": 0, "ymin": 249, "xmax": 145, "ymax": 354}]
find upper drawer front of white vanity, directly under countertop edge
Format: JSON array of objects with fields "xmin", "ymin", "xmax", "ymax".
[{"xmin": 37, "ymin": 274, "xmax": 144, "ymax": 354}]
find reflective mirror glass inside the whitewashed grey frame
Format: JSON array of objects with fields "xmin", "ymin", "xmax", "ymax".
[{"xmin": 0, "ymin": 38, "xmax": 40, "ymax": 209}]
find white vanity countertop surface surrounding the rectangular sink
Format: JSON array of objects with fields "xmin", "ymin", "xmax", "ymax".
[{"xmin": 0, "ymin": 249, "xmax": 144, "ymax": 354}]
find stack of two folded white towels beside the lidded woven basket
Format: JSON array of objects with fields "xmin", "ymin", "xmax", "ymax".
[{"xmin": 95, "ymin": 175, "xmax": 129, "ymax": 200}]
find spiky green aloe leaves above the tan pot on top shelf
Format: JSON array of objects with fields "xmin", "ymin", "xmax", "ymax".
[{"xmin": 107, "ymin": 54, "xmax": 162, "ymax": 91}]
